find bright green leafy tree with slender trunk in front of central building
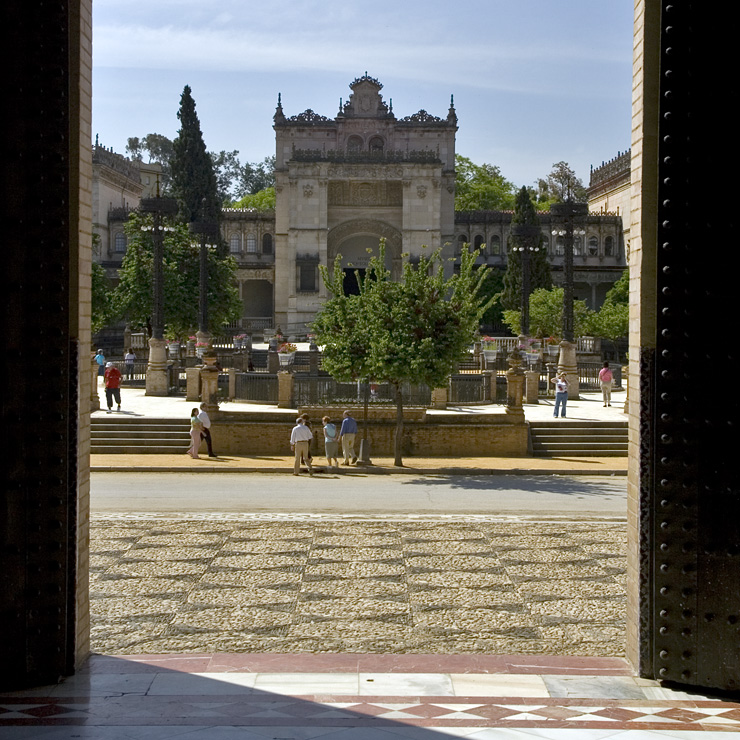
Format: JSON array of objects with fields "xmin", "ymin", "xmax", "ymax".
[{"xmin": 313, "ymin": 242, "xmax": 488, "ymax": 466}]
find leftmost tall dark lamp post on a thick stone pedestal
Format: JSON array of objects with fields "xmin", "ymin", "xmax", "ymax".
[{"xmin": 139, "ymin": 192, "xmax": 177, "ymax": 396}]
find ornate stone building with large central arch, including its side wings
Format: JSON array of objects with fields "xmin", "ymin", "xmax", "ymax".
[{"xmin": 93, "ymin": 74, "xmax": 629, "ymax": 335}]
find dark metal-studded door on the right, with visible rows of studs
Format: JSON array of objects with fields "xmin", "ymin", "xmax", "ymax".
[{"xmin": 652, "ymin": 2, "xmax": 740, "ymax": 690}]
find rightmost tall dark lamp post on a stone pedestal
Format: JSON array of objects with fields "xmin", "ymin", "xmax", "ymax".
[{"xmin": 550, "ymin": 196, "xmax": 588, "ymax": 398}]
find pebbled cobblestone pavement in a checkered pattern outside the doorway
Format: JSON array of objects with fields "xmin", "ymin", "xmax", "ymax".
[{"xmin": 90, "ymin": 514, "xmax": 626, "ymax": 656}]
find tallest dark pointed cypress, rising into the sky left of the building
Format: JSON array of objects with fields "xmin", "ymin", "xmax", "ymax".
[{"xmin": 172, "ymin": 85, "xmax": 221, "ymax": 223}]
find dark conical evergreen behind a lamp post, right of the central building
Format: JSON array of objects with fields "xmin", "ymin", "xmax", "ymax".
[{"xmin": 501, "ymin": 187, "xmax": 552, "ymax": 310}]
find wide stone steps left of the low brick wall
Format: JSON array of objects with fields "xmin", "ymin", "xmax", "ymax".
[{"xmin": 90, "ymin": 415, "xmax": 190, "ymax": 455}]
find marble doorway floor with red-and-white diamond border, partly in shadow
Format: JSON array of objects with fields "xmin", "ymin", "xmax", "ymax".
[{"xmin": 0, "ymin": 653, "xmax": 740, "ymax": 740}]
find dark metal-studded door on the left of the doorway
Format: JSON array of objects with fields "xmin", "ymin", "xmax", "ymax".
[{"xmin": 0, "ymin": 0, "xmax": 79, "ymax": 688}]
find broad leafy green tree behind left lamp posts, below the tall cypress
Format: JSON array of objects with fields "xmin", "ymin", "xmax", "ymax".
[{"xmin": 113, "ymin": 211, "xmax": 241, "ymax": 337}]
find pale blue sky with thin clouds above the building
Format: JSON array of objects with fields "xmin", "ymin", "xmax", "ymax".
[{"xmin": 93, "ymin": 0, "xmax": 633, "ymax": 186}]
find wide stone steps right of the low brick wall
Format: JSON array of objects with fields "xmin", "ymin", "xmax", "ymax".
[{"xmin": 529, "ymin": 419, "xmax": 627, "ymax": 457}]
